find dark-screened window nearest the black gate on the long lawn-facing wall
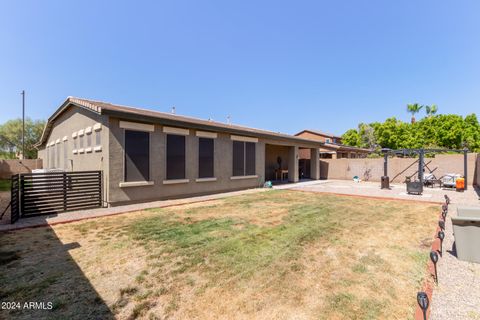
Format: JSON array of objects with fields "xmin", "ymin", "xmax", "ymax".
[{"xmin": 124, "ymin": 130, "xmax": 150, "ymax": 182}]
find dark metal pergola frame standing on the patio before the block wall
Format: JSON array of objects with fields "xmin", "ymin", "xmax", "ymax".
[{"xmin": 382, "ymin": 148, "xmax": 469, "ymax": 190}]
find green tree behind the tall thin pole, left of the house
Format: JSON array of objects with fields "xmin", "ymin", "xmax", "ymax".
[{"xmin": 0, "ymin": 118, "xmax": 45, "ymax": 159}]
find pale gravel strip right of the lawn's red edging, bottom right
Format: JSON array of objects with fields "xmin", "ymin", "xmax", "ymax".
[{"xmin": 430, "ymin": 205, "xmax": 480, "ymax": 320}]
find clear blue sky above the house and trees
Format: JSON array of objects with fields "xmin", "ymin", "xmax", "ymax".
[{"xmin": 0, "ymin": 0, "xmax": 480, "ymax": 134}]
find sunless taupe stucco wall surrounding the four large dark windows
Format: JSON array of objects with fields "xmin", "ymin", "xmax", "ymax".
[{"xmin": 109, "ymin": 118, "xmax": 265, "ymax": 205}]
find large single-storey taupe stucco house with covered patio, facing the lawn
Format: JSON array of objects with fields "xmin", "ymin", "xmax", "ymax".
[{"xmin": 37, "ymin": 97, "xmax": 324, "ymax": 205}]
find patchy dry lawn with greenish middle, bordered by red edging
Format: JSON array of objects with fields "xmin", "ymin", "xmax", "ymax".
[{"xmin": 0, "ymin": 191, "xmax": 437, "ymax": 319}]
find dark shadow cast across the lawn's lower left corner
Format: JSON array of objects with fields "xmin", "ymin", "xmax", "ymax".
[{"xmin": 0, "ymin": 227, "xmax": 114, "ymax": 319}]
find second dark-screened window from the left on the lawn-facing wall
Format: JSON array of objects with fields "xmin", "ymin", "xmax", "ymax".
[{"xmin": 167, "ymin": 134, "xmax": 185, "ymax": 180}]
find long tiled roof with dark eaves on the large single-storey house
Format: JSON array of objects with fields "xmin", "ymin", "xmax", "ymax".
[{"xmin": 36, "ymin": 97, "xmax": 323, "ymax": 147}]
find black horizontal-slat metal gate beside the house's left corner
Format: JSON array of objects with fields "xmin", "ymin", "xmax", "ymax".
[{"xmin": 11, "ymin": 171, "xmax": 103, "ymax": 223}]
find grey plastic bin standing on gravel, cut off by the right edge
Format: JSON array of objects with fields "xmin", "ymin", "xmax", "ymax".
[{"xmin": 451, "ymin": 207, "xmax": 480, "ymax": 263}]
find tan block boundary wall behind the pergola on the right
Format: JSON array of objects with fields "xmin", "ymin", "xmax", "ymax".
[{"xmin": 320, "ymin": 153, "xmax": 480, "ymax": 184}]
